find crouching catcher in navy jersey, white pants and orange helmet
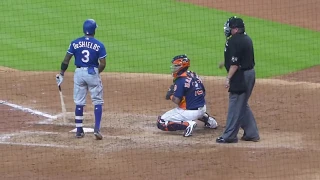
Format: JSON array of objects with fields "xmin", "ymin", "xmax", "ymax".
[{"xmin": 157, "ymin": 55, "xmax": 218, "ymax": 137}]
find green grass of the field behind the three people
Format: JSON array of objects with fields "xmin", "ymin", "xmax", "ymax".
[{"xmin": 0, "ymin": 0, "xmax": 320, "ymax": 77}]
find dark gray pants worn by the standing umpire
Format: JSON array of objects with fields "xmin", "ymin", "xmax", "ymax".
[{"xmin": 222, "ymin": 69, "xmax": 259, "ymax": 140}]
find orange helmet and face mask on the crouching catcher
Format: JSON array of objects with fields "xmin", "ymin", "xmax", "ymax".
[{"xmin": 171, "ymin": 54, "xmax": 190, "ymax": 78}]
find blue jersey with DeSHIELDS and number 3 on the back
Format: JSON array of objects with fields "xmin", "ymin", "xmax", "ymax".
[{"xmin": 67, "ymin": 36, "xmax": 107, "ymax": 67}]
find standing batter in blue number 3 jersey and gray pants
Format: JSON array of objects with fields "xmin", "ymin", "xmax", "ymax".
[{"xmin": 56, "ymin": 19, "xmax": 107, "ymax": 140}]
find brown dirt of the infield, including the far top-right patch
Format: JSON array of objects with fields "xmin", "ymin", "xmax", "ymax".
[{"xmin": 0, "ymin": 0, "xmax": 320, "ymax": 180}]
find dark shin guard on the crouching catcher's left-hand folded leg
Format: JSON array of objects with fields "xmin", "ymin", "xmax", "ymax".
[{"xmin": 157, "ymin": 116, "xmax": 189, "ymax": 131}]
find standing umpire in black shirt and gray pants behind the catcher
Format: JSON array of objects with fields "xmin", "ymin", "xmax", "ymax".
[{"xmin": 216, "ymin": 16, "xmax": 260, "ymax": 143}]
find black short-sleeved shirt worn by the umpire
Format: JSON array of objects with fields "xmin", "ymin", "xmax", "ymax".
[{"xmin": 224, "ymin": 33, "xmax": 255, "ymax": 93}]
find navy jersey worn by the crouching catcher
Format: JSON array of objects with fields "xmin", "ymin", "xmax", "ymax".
[{"xmin": 173, "ymin": 71, "xmax": 206, "ymax": 110}]
